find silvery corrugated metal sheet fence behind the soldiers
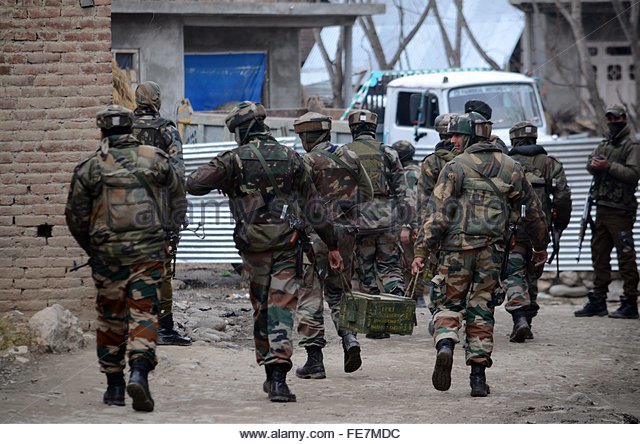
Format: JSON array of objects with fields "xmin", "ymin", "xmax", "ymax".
[{"xmin": 178, "ymin": 137, "xmax": 640, "ymax": 271}]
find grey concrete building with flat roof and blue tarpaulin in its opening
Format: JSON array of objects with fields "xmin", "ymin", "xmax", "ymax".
[{"xmin": 112, "ymin": 0, "xmax": 385, "ymax": 118}]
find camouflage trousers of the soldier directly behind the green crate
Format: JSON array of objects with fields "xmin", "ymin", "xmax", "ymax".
[{"xmin": 356, "ymin": 230, "xmax": 404, "ymax": 294}]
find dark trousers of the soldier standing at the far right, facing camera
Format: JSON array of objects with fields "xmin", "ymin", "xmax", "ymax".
[{"xmin": 591, "ymin": 206, "xmax": 639, "ymax": 297}]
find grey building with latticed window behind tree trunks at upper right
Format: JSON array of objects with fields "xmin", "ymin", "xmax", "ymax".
[{"xmin": 510, "ymin": 0, "xmax": 635, "ymax": 122}]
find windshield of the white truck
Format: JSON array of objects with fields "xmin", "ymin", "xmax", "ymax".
[{"xmin": 449, "ymin": 83, "xmax": 542, "ymax": 128}]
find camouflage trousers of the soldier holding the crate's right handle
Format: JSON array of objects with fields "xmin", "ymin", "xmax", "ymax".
[{"xmin": 431, "ymin": 245, "xmax": 502, "ymax": 367}]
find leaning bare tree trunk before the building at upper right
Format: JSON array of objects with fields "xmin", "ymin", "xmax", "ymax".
[{"xmin": 555, "ymin": 0, "xmax": 606, "ymax": 133}]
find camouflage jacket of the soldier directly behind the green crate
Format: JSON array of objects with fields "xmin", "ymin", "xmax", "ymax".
[{"xmin": 345, "ymin": 135, "xmax": 412, "ymax": 233}]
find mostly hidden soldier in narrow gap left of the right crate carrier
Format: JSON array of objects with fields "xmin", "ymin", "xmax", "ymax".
[{"xmin": 391, "ymin": 140, "xmax": 426, "ymax": 308}]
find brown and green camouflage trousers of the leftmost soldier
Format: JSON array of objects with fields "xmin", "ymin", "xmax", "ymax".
[{"xmin": 91, "ymin": 261, "xmax": 164, "ymax": 373}]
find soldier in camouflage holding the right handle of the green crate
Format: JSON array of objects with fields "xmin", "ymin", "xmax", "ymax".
[{"xmin": 413, "ymin": 113, "xmax": 548, "ymax": 396}]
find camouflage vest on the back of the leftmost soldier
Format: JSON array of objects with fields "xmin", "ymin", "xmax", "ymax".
[{"xmin": 92, "ymin": 145, "xmax": 168, "ymax": 238}]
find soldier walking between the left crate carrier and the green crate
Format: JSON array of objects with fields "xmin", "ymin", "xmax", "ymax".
[{"xmin": 293, "ymin": 112, "xmax": 373, "ymax": 379}]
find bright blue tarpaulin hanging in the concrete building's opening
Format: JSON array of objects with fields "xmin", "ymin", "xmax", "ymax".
[{"xmin": 184, "ymin": 53, "xmax": 266, "ymax": 111}]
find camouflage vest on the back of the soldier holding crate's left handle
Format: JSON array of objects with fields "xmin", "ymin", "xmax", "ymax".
[{"xmin": 230, "ymin": 140, "xmax": 302, "ymax": 252}]
